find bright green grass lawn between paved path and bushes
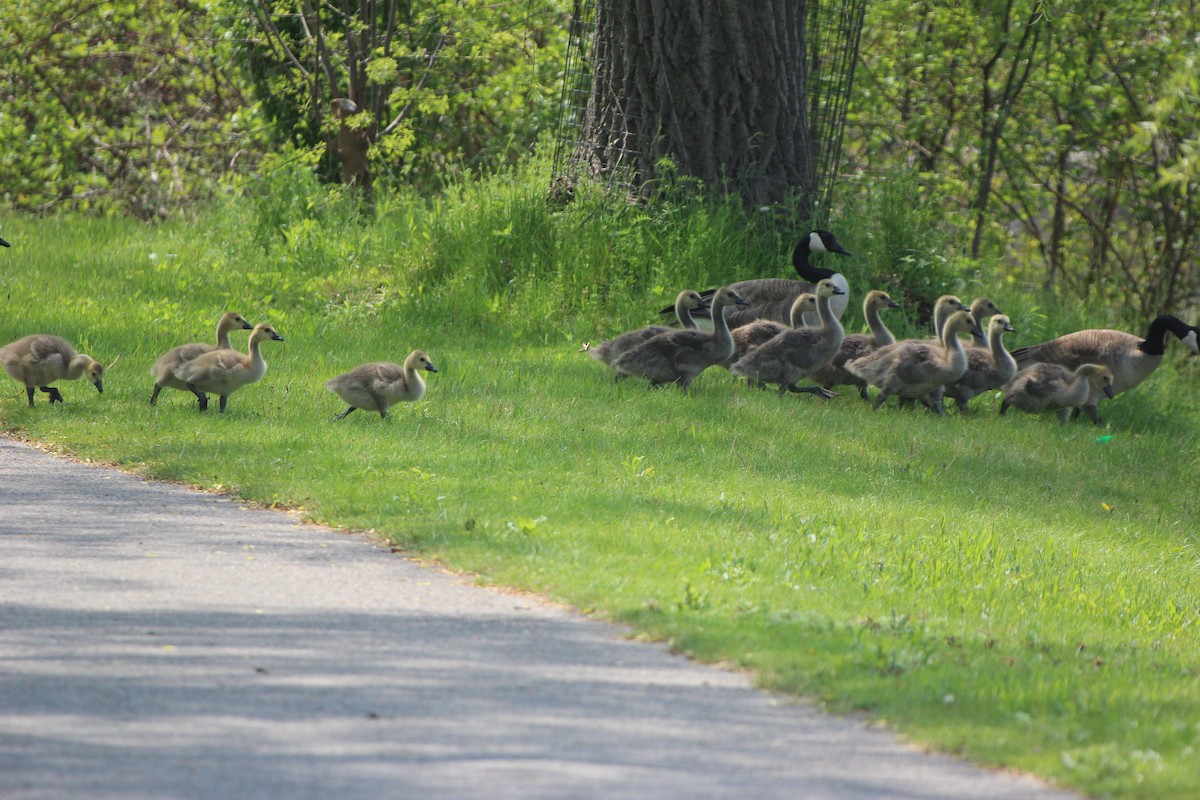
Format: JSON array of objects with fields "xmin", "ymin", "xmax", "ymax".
[{"xmin": 0, "ymin": 165, "xmax": 1200, "ymax": 799}]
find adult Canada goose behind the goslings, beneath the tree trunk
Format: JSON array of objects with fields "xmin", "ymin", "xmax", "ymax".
[{"xmin": 664, "ymin": 230, "xmax": 850, "ymax": 327}]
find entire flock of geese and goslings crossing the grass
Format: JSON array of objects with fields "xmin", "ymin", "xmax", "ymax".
[{"xmin": 0, "ymin": 230, "xmax": 1200, "ymax": 425}]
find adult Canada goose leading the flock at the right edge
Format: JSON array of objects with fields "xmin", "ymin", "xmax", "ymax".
[{"xmin": 1013, "ymin": 314, "xmax": 1200, "ymax": 421}]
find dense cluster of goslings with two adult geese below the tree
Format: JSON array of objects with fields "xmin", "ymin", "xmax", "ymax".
[{"xmin": 583, "ymin": 230, "xmax": 1200, "ymax": 425}]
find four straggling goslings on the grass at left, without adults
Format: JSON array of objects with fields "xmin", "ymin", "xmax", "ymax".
[{"xmin": 0, "ymin": 312, "xmax": 437, "ymax": 420}]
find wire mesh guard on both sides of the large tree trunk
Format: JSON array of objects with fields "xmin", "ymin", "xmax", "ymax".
[{"xmin": 553, "ymin": 0, "xmax": 866, "ymax": 223}]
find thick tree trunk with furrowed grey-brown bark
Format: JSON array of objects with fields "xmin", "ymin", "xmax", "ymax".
[{"xmin": 576, "ymin": 0, "xmax": 816, "ymax": 204}]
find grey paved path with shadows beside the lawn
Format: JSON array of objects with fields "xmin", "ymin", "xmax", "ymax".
[{"xmin": 0, "ymin": 438, "xmax": 1074, "ymax": 800}]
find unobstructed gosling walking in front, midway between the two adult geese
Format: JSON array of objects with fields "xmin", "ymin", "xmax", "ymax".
[{"xmin": 846, "ymin": 311, "xmax": 978, "ymax": 416}]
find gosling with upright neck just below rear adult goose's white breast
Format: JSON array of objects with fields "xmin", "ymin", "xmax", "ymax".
[{"xmin": 730, "ymin": 278, "xmax": 845, "ymax": 398}]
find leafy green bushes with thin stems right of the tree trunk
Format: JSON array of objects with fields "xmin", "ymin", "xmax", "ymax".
[{"xmin": 846, "ymin": 0, "xmax": 1200, "ymax": 317}]
